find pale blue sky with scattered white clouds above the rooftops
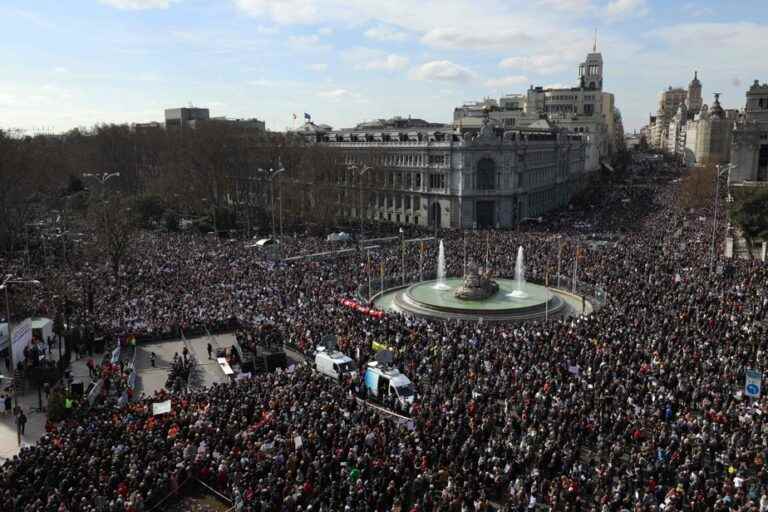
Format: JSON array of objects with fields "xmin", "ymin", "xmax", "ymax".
[{"xmin": 0, "ymin": 0, "xmax": 768, "ymax": 132}]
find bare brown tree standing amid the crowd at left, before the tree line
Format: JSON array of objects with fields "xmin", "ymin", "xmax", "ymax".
[{"xmin": 93, "ymin": 194, "xmax": 135, "ymax": 280}]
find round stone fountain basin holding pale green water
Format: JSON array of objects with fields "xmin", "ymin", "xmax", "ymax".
[{"xmin": 374, "ymin": 278, "xmax": 565, "ymax": 321}]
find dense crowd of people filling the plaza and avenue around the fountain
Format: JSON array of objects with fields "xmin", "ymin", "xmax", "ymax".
[{"xmin": 0, "ymin": 157, "xmax": 768, "ymax": 512}]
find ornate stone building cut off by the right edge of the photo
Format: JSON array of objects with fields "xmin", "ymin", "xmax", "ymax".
[{"xmin": 730, "ymin": 80, "xmax": 768, "ymax": 185}]
